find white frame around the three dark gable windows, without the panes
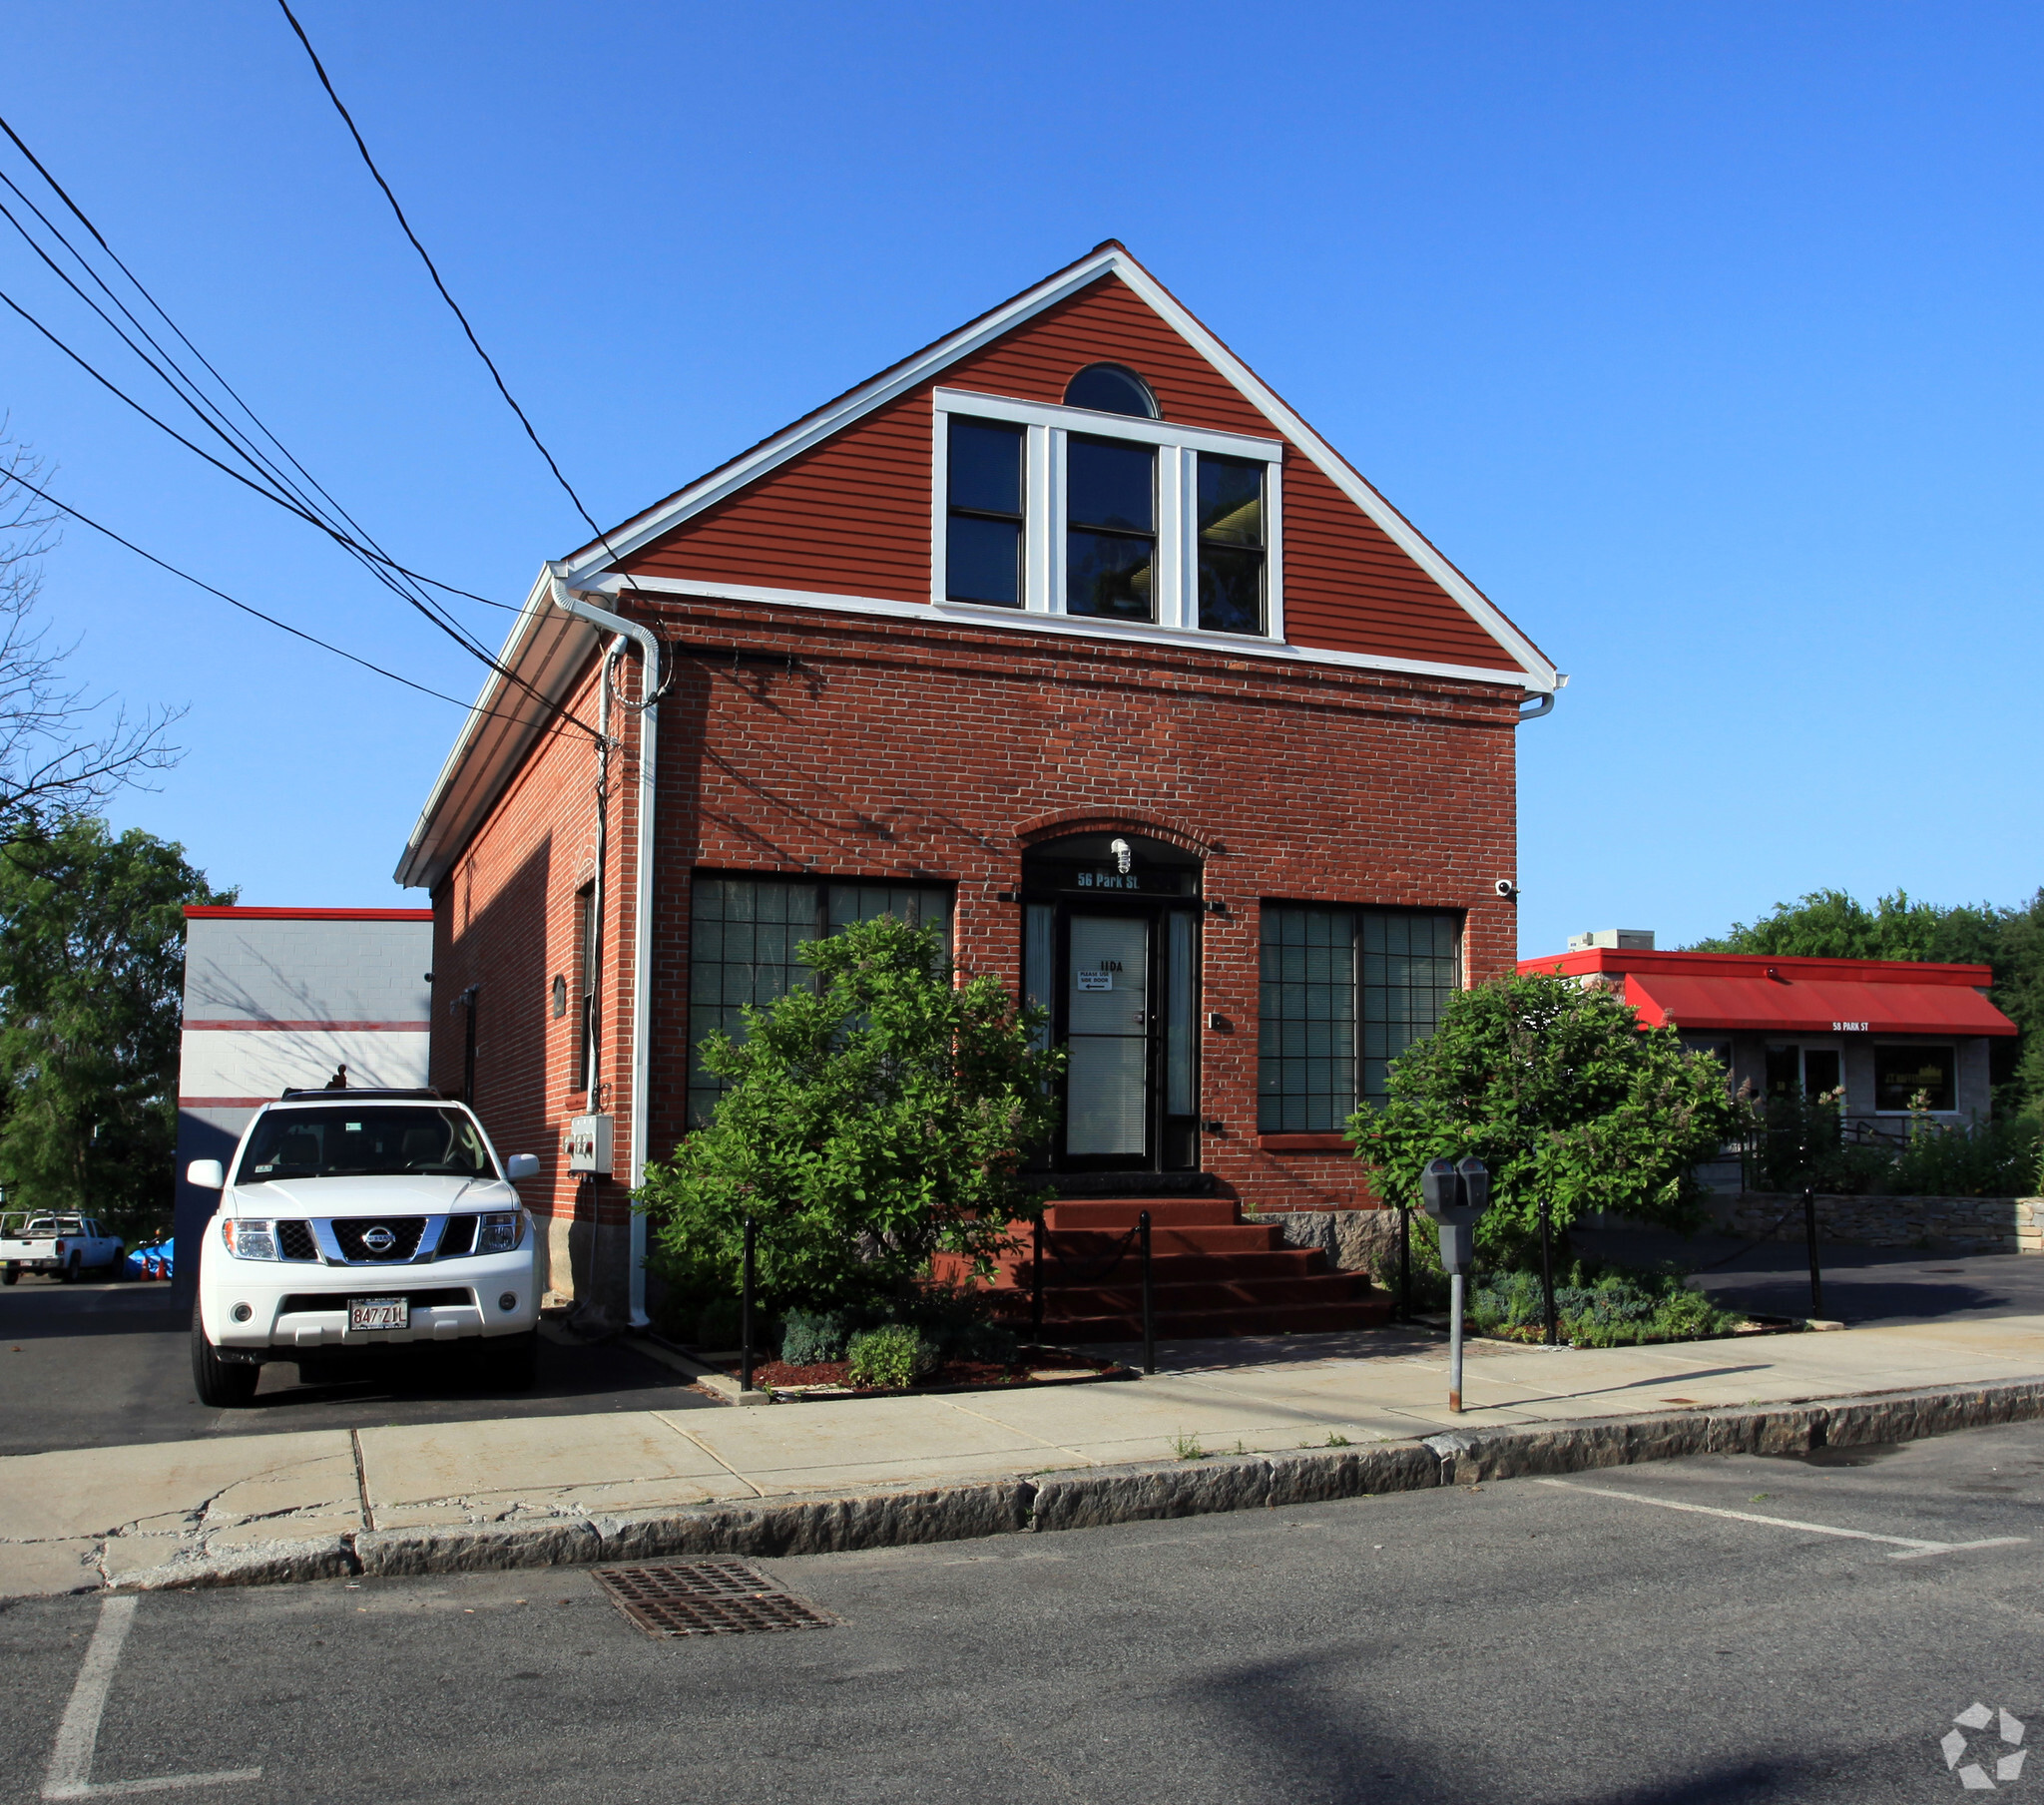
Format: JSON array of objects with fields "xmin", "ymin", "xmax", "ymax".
[{"xmin": 930, "ymin": 388, "xmax": 1283, "ymax": 646}]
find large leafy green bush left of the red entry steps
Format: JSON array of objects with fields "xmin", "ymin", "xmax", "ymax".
[{"xmin": 638, "ymin": 916, "xmax": 1063, "ymax": 1308}]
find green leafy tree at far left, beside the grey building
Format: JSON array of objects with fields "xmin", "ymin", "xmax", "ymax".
[{"xmin": 0, "ymin": 815, "xmax": 236, "ymax": 1232}]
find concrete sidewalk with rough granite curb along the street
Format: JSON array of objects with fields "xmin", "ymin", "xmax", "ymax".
[{"xmin": 0, "ymin": 1314, "xmax": 2044, "ymax": 1596}]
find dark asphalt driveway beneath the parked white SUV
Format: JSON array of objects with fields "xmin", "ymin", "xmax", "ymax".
[{"xmin": 0, "ymin": 1277, "xmax": 724, "ymax": 1454}]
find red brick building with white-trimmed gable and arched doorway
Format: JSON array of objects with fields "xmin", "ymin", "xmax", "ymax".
[{"xmin": 398, "ymin": 243, "xmax": 1562, "ymax": 1312}]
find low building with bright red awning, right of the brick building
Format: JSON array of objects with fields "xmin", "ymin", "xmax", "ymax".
[{"xmin": 1519, "ymin": 928, "xmax": 2017, "ymax": 1134}]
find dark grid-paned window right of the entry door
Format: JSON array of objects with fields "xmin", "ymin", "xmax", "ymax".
[{"xmin": 1258, "ymin": 904, "xmax": 1461, "ymax": 1134}]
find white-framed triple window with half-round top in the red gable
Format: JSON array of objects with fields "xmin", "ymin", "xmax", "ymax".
[{"xmin": 930, "ymin": 384, "xmax": 1283, "ymax": 640}]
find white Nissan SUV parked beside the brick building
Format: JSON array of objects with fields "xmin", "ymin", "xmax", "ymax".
[{"xmin": 186, "ymin": 1090, "xmax": 540, "ymax": 1409}]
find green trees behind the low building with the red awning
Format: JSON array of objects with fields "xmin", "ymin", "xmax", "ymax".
[{"xmin": 1693, "ymin": 889, "xmax": 2044, "ymax": 1115}]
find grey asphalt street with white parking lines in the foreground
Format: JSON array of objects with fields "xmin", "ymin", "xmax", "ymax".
[{"xmin": 0, "ymin": 1425, "xmax": 2044, "ymax": 1805}]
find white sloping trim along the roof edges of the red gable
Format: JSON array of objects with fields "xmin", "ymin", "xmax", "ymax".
[{"xmin": 564, "ymin": 239, "xmax": 1562, "ymax": 695}]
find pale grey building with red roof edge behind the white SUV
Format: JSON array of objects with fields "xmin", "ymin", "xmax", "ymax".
[{"xmin": 176, "ymin": 906, "xmax": 433, "ymax": 1296}]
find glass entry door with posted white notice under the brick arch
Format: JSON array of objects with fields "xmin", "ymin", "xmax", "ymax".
[{"xmin": 1065, "ymin": 912, "xmax": 1155, "ymax": 1159}]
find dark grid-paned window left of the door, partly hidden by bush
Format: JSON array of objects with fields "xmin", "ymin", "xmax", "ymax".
[{"xmin": 689, "ymin": 877, "xmax": 950, "ymax": 1128}]
